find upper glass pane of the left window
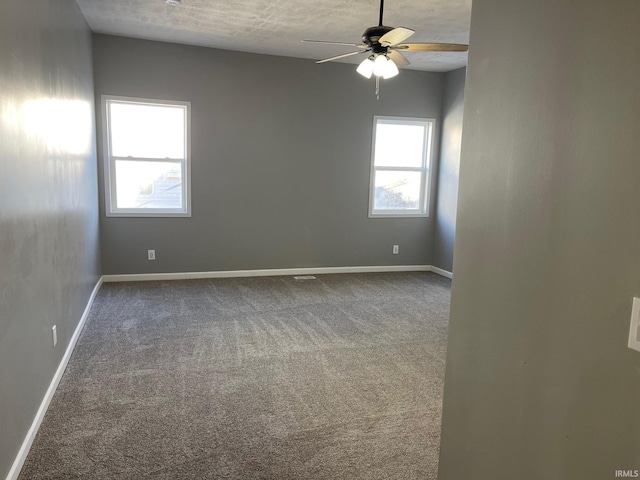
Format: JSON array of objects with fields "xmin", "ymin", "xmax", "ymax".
[{"xmin": 109, "ymin": 102, "xmax": 185, "ymax": 159}]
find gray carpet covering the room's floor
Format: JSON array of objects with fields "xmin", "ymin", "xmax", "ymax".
[{"xmin": 20, "ymin": 273, "xmax": 450, "ymax": 480}]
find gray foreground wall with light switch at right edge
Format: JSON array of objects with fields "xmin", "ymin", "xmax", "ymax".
[{"xmin": 439, "ymin": 0, "xmax": 640, "ymax": 480}]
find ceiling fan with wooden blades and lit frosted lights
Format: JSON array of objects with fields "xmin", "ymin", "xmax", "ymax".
[{"xmin": 303, "ymin": 0, "xmax": 469, "ymax": 86}]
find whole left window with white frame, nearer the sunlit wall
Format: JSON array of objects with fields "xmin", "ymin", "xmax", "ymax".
[{"xmin": 102, "ymin": 96, "xmax": 191, "ymax": 217}]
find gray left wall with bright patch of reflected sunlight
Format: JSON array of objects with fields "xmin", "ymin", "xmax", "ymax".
[{"xmin": 0, "ymin": 0, "xmax": 99, "ymax": 478}]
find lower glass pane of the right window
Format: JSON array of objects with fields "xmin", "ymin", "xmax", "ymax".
[{"xmin": 373, "ymin": 170, "xmax": 422, "ymax": 210}]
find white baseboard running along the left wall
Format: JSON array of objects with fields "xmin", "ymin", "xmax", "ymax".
[{"xmin": 6, "ymin": 277, "xmax": 103, "ymax": 480}]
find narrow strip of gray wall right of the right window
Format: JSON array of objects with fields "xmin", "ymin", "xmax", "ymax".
[{"xmin": 433, "ymin": 68, "xmax": 466, "ymax": 272}]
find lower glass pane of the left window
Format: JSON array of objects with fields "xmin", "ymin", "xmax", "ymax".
[{"xmin": 116, "ymin": 160, "xmax": 183, "ymax": 208}]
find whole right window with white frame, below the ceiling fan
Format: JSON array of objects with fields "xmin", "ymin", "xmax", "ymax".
[{"xmin": 369, "ymin": 116, "xmax": 435, "ymax": 217}]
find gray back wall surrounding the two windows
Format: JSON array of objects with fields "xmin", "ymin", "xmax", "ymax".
[{"xmin": 94, "ymin": 35, "xmax": 444, "ymax": 274}]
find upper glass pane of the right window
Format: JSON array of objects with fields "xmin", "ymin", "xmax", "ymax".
[{"xmin": 373, "ymin": 121, "xmax": 427, "ymax": 168}]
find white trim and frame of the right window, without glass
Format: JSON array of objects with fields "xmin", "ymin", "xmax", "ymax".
[{"xmin": 369, "ymin": 115, "xmax": 436, "ymax": 218}]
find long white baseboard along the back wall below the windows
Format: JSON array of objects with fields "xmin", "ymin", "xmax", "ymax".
[{"xmin": 102, "ymin": 265, "xmax": 436, "ymax": 282}]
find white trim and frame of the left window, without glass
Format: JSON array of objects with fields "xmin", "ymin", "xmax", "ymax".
[{"xmin": 102, "ymin": 95, "xmax": 191, "ymax": 217}]
